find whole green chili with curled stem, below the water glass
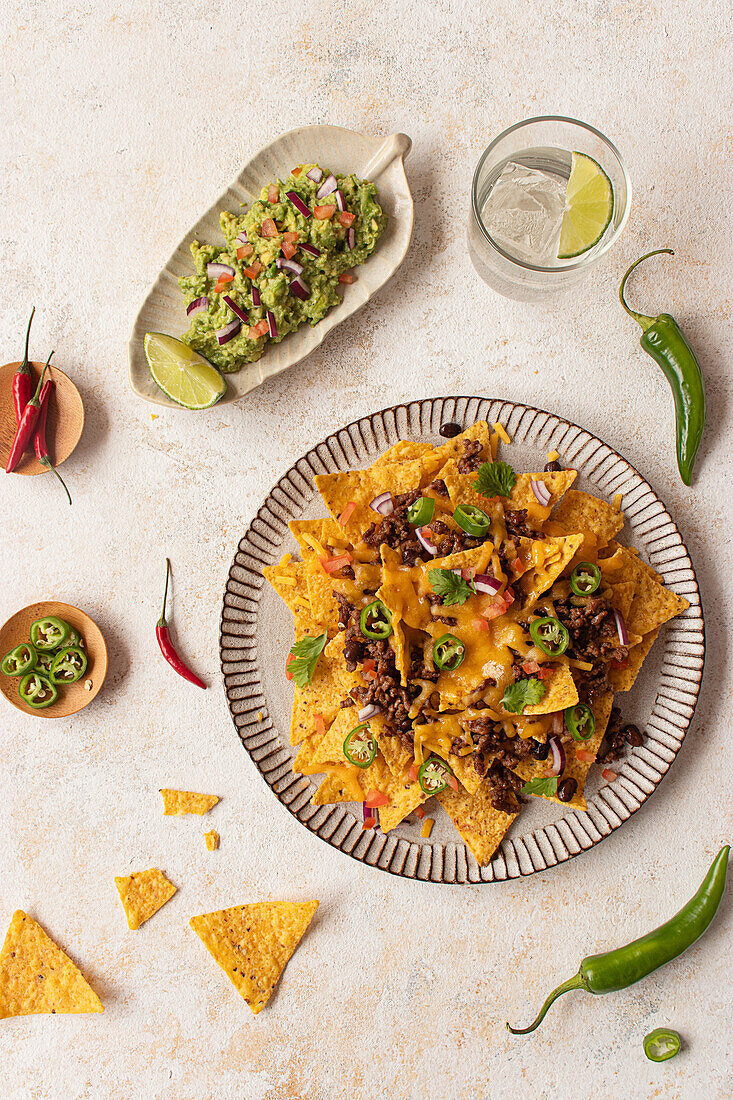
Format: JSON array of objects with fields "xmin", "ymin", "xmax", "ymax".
[{"xmin": 619, "ymin": 249, "xmax": 705, "ymax": 485}]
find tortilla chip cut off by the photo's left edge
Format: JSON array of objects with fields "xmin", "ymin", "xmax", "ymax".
[{"xmin": 0, "ymin": 909, "xmax": 105, "ymax": 1020}]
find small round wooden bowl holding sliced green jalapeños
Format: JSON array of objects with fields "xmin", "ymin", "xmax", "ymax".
[{"xmin": 0, "ymin": 600, "xmax": 108, "ymax": 718}]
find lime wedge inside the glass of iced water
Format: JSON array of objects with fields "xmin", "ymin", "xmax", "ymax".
[{"xmin": 557, "ymin": 153, "xmax": 613, "ymax": 260}]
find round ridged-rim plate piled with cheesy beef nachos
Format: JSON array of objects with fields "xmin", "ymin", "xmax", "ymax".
[{"xmin": 221, "ymin": 398, "xmax": 704, "ymax": 882}]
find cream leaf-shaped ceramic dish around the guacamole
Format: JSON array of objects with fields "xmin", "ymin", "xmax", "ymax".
[{"xmin": 128, "ymin": 127, "xmax": 413, "ymax": 408}]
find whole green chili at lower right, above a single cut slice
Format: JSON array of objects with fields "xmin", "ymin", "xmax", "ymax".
[{"xmin": 506, "ymin": 844, "xmax": 731, "ymax": 1035}]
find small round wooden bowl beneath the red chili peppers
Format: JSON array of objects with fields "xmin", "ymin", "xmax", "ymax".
[{"xmin": 0, "ymin": 361, "xmax": 84, "ymax": 474}]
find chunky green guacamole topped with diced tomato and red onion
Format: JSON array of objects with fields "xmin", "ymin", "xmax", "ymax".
[{"xmin": 178, "ymin": 164, "xmax": 387, "ymax": 373}]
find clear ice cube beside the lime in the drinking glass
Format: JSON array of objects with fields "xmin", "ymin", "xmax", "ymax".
[{"xmin": 481, "ymin": 161, "xmax": 567, "ymax": 267}]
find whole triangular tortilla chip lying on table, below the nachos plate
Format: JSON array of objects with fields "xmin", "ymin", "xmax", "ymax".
[{"xmin": 188, "ymin": 901, "xmax": 318, "ymax": 1015}]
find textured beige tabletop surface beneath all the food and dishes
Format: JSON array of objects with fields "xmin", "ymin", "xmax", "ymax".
[{"xmin": 0, "ymin": 0, "xmax": 733, "ymax": 1100}]
